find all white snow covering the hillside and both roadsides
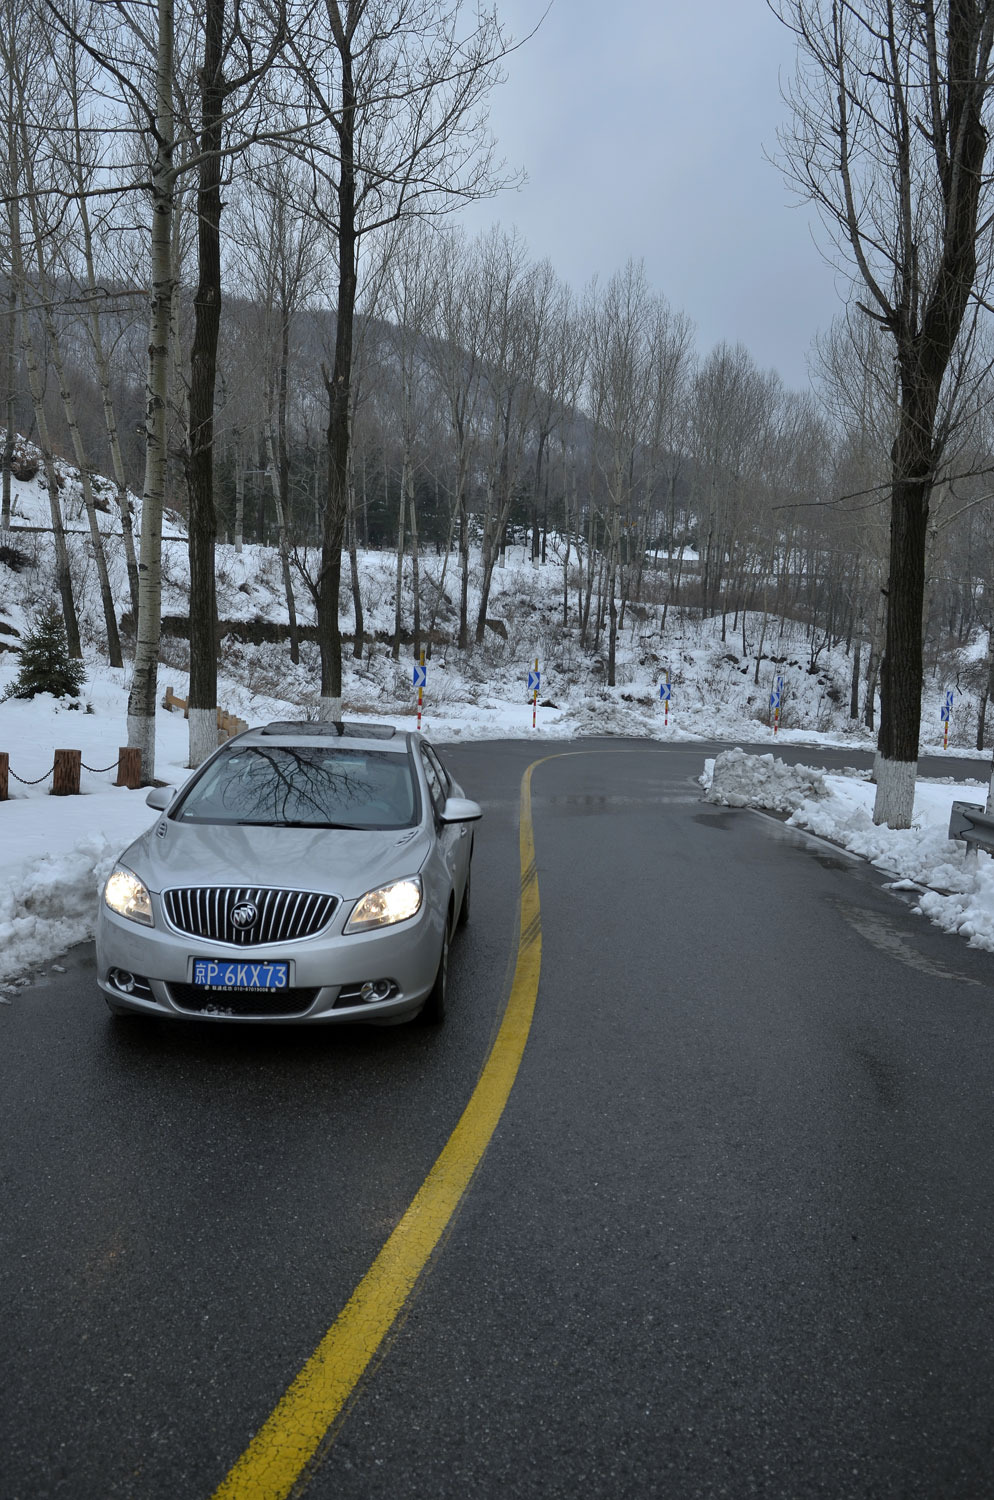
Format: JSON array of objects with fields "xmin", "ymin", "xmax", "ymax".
[{"xmin": 0, "ymin": 438, "xmax": 994, "ymax": 989}]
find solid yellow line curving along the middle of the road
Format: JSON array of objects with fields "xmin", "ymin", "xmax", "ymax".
[{"xmin": 213, "ymin": 756, "xmax": 553, "ymax": 1500}]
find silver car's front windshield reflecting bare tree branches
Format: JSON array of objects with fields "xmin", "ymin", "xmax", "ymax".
[{"xmin": 174, "ymin": 746, "xmax": 420, "ymax": 828}]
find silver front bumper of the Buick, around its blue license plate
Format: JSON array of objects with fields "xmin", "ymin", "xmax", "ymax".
[{"xmin": 96, "ymin": 897, "xmax": 444, "ymax": 1025}]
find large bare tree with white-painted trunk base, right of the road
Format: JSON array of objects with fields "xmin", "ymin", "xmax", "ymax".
[{"xmin": 771, "ymin": 0, "xmax": 994, "ymax": 828}]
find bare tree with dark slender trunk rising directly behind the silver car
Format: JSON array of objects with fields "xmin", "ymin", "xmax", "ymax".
[{"xmin": 280, "ymin": 0, "xmax": 507, "ymax": 719}]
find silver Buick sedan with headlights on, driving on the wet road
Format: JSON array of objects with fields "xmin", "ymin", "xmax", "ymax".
[{"xmin": 96, "ymin": 723, "xmax": 481, "ymax": 1025}]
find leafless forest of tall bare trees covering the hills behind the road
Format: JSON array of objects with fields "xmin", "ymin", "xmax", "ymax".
[{"xmin": 0, "ymin": 0, "xmax": 994, "ymax": 827}]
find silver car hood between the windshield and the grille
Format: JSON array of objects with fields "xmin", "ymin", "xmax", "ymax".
[{"xmin": 120, "ymin": 818, "xmax": 432, "ymax": 900}]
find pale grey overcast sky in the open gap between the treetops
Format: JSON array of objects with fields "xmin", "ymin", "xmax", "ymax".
[{"xmin": 462, "ymin": 0, "xmax": 841, "ymax": 389}]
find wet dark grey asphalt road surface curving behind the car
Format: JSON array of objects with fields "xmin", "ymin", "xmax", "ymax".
[{"xmin": 0, "ymin": 741, "xmax": 994, "ymax": 1500}]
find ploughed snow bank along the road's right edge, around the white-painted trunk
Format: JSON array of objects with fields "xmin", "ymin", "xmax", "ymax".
[{"xmin": 700, "ymin": 749, "xmax": 994, "ymax": 953}]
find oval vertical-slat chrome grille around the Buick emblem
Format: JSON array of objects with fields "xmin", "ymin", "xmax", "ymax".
[{"xmin": 162, "ymin": 885, "xmax": 339, "ymax": 948}]
